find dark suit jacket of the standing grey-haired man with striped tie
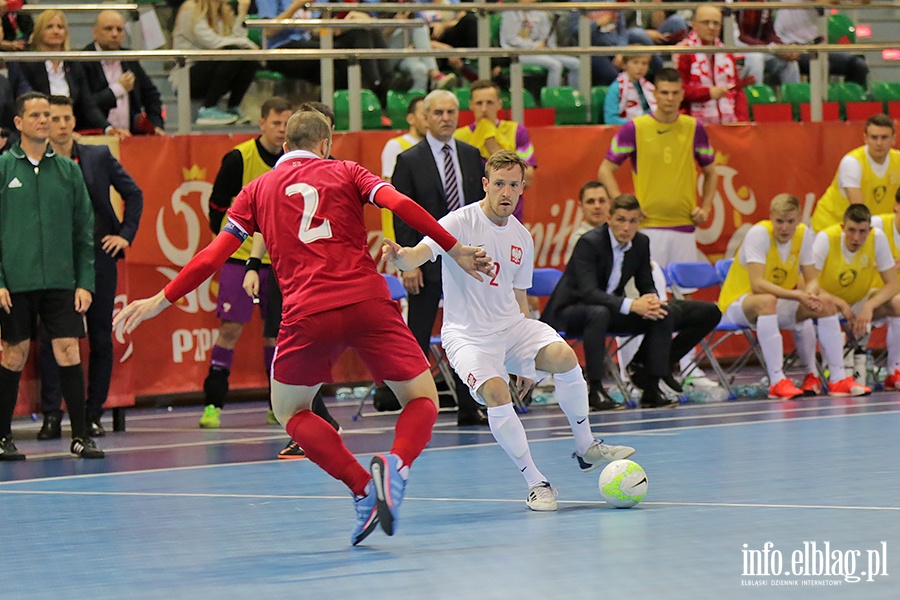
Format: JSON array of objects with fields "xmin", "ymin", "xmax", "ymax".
[{"xmin": 391, "ymin": 139, "xmax": 484, "ymax": 281}]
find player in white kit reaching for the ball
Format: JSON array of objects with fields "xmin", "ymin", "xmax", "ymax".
[{"xmin": 383, "ymin": 150, "xmax": 634, "ymax": 511}]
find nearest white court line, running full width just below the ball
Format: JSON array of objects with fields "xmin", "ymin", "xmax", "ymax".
[{"xmin": 0, "ymin": 490, "xmax": 900, "ymax": 512}]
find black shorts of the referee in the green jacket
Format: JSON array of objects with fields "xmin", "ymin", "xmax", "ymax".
[{"xmin": 0, "ymin": 290, "xmax": 84, "ymax": 344}]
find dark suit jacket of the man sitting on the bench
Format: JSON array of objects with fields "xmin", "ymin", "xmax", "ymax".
[{"xmin": 541, "ymin": 225, "xmax": 656, "ymax": 330}]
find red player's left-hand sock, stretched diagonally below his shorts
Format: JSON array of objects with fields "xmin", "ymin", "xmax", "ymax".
[{"xmin": 285, "ymin": 410, "xmax": 372, "ymax": 496}]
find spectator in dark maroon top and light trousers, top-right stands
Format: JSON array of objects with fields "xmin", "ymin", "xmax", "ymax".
[{"xmin": 734, "ymin": 0, "xmax": 800, "ymax": 84}]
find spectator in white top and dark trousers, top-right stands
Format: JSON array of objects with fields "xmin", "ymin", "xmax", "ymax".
[{"xmin": 775, "ymin": 0, "xmax": 869, "ymax": 87}]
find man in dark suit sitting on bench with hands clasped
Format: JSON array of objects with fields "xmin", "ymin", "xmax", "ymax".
[{"xmin": 541, "ymin": 194, "xmax": 722, "ymax": 407}]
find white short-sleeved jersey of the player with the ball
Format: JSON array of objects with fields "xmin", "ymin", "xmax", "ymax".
[{"xmin": 422, "ymin": 203, "xmax": 534, "ymax": 337}]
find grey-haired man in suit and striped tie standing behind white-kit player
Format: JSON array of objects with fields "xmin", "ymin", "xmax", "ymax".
[{"xmin": 391, "ymin": 90, "xmax": 487, "ymax": 426}]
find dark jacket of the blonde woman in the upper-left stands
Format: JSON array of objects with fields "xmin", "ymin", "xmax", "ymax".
[{"xmin": 9, "ymin": 62, "xmax": 109, "ymax": 130}]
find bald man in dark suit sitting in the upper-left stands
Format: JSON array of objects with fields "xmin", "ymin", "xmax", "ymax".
[{"xmin": 83, "ymin": 10, "xmax": 166, "ymax": 135}]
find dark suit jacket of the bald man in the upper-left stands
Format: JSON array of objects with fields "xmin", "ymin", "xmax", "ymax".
[{"xmin": 81, "ymin": 42, "xmax": 165, "ymax": 133}]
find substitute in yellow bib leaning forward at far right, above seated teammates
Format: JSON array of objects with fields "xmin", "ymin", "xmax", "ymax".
[{"xmin": 812, "ymin": 115, "xmax": 900, "ymax": 231}]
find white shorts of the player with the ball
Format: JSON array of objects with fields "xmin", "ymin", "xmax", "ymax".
[{"xmin": 441, "ymin": 319, "xmax": 565, "ymax": 404}]
